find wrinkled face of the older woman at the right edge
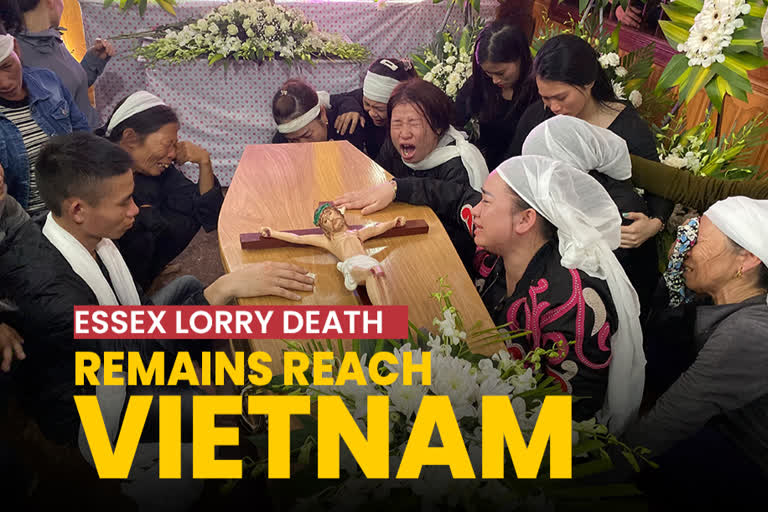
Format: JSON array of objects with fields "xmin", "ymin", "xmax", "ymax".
[{"xmin": 683, "ymin": 216, "xmax": 739, "ymax": 295}]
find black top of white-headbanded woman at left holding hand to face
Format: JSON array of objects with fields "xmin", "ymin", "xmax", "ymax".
[{"xmin": 117, "ymin": 165, "xmax": 224, "ymax": 287}]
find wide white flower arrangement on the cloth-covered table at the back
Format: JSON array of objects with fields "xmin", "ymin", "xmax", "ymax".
[{"xmin": 127, "ymin": 0, "xmax": 370, "ymax": 65}]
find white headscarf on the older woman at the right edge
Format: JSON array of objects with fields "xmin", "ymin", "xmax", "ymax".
[{"xmin": 704, "ymin": 196, "xmax": 768, "ymax": 302}]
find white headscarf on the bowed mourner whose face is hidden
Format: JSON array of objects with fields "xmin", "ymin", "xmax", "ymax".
[{"xmin": 523, "ymin": 116, "xmax": 632, "ymax": 180}]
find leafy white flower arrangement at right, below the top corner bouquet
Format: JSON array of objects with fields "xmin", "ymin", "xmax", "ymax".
[{"xmin": 656, "ymin": 111, "xmax": 768, "ymax": 180}]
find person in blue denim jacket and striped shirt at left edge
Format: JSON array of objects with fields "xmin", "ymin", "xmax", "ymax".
[{"xmin": 0, "ymin": 26, "xmax": 89, "ymax": 216}]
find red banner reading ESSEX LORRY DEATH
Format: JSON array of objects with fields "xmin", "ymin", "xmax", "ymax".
[{"xmin": 74, "ymin": 306, "xmax": 408, "ymax": 340}]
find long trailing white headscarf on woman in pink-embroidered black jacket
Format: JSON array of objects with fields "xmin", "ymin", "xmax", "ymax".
[{"xmin": 496, "ymin": 156, "xmax": 645, "ymax": 434}]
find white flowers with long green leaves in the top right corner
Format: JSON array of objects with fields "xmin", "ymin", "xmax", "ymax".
[{"xmin": 657, "ymin": 0, "xmax": 768, "ymax": 110}]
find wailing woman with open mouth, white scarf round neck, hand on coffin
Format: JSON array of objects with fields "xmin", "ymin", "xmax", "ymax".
[{"xmin": 334, "ymin": 79, "xmax": 488, "ymax": 265}]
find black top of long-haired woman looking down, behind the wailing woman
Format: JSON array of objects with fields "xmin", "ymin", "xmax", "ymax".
[{"xmin": 455, "ymin": 79, "xmax": 539, "ymax": 170}]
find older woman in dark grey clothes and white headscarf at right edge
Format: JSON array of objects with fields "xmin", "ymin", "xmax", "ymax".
[{"xmin": 627, "ymin": 196, "xmax": 768, "ymax": 499}]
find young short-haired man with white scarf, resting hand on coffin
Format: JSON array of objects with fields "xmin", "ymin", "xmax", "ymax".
[{"xmin": 0, "ymin": 133, "xmax": 313, "ymax": 504}]
